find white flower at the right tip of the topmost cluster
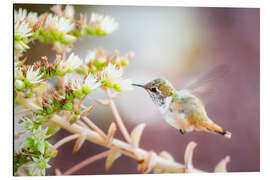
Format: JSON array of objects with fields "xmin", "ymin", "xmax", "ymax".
[{"xmin": 90, "ymin": 13, "xmax": 118, "ymax": 33}]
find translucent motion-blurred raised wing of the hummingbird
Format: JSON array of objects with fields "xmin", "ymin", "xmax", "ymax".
[{"xmin": 184, "ymin": 64, "xmax": 230, "ymax": 104}]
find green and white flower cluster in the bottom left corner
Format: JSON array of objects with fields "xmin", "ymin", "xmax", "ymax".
[{"xmin": 14, "ymin": 117, "xmax": 56, "ymax": 175}]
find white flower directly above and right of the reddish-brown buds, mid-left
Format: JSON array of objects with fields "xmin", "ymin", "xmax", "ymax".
[{"xmin": 58, "ymin": 53, "xmax": 82, "ymax": 73}]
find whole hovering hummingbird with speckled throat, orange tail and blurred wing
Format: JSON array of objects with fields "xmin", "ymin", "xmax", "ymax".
[{"xmin": 132, "ymin": 65, "xmax": 231, "ymax": 138}]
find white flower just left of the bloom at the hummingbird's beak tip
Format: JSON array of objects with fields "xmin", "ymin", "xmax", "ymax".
[{"xmin": 101, "ymin": 64, "xmax": 123, "ymax": 84}]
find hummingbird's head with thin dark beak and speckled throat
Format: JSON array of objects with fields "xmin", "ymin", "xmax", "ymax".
[{"xmin": 132, "ymin": 78, "xmax": 175, "ymax": 106}]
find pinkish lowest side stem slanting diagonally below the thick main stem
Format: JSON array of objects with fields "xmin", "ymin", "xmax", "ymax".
[{"xmin": 63, "ymin": 150, "xmax": 112, "ymax": 175}]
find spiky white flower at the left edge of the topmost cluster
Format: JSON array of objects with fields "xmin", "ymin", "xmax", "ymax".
[{"xmin": 14, "ymin": 22, "xmax": 33, "ymax": 38}]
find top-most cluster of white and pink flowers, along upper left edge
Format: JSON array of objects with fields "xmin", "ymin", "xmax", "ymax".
[{"xmin": 14, "ymin": 5, "xmax": 118, "ymax": 60}]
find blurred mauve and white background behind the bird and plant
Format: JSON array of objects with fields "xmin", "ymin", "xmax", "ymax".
[{"xmin": 14, "ymin": 4, "xmax": 260, "ymax": 175}]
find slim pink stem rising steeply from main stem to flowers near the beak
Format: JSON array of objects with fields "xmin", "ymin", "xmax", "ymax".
[{"xmin": 105, "ymin": 87, "xmax": 132, "ymax": 144}]
